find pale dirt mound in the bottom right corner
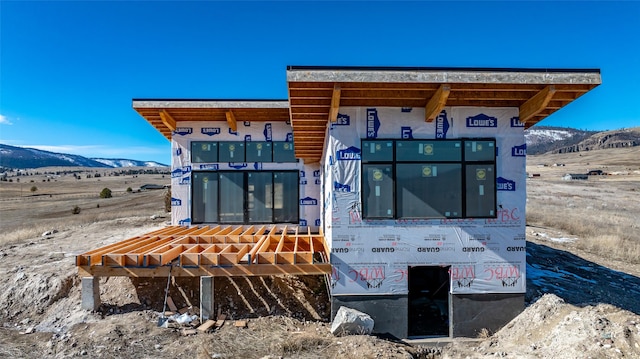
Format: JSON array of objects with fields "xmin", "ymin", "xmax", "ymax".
[{"xmin": 470, "ymin": 294, "xmax": 640, "ymax": 358}]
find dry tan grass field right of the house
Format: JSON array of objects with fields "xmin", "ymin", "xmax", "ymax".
[{"xmin": 527, "ymin": 147, "xmax": 640, "ymax": 264}]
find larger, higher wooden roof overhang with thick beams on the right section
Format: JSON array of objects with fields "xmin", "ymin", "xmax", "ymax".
[{"xmin": 287, "ymin": 66, "xmax": 601, "ymax": 162}]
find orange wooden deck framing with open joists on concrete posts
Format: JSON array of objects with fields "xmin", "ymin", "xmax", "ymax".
[{"xmin": 76, "ymin": 225, "xmax": 331, "ymax": 277}]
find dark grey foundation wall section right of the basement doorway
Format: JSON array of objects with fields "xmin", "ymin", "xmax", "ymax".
[{"xmin": 451, "ymin": 293, "xmax": 524, "ymax": 338}]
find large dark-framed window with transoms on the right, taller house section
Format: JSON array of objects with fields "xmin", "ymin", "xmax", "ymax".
[{"xmin": 362, "ymin": 139, "xmax": 496, "ymax": 219}]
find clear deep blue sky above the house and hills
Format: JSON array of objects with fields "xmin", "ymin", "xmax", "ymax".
[{"xmin": 0, "ymin": 0, "xmax": 640, "ymax": 164}]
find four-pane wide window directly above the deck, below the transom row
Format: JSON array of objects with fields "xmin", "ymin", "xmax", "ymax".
[{"xmin": 191, "ymin": 171, "xmax": 299, "ymax": 224}]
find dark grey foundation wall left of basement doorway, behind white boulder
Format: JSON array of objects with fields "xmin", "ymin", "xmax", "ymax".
[{"xmin": 331, "ymin": 295, "xmax": 409, "ymax": 338}]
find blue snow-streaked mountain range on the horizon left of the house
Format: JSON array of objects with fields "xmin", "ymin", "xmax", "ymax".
[{"xmin": 0, "ymin": 144, "xmax": 167, "ymax": 169}]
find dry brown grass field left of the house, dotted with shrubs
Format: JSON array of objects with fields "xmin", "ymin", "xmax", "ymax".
[{"xmin": 0, "ymin": 167, "xmax": 171, "ymax": 244}]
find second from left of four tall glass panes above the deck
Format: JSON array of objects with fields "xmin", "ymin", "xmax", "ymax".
[{"xmin": 220, "ymin": 172, "xmax": 244, "ymax": 223}]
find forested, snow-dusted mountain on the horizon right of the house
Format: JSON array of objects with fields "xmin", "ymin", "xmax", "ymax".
[{"xmin": 525, "ymin": 126, "xmax": 640, "ymax": 155}]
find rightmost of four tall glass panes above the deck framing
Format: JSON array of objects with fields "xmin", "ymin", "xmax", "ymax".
[{"xmin": 273, "ymin": 171, "xmax": 300, "ymax": 223}]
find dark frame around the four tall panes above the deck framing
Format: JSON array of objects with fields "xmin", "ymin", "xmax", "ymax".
[{"xmin": 190, "ymin": 170, "xmax": 300, "ymax": 225}]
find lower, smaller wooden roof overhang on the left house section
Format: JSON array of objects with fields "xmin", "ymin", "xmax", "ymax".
[{"xmin": 133, "ymin": 99, "xmax": 290, "ymax": 140}]
